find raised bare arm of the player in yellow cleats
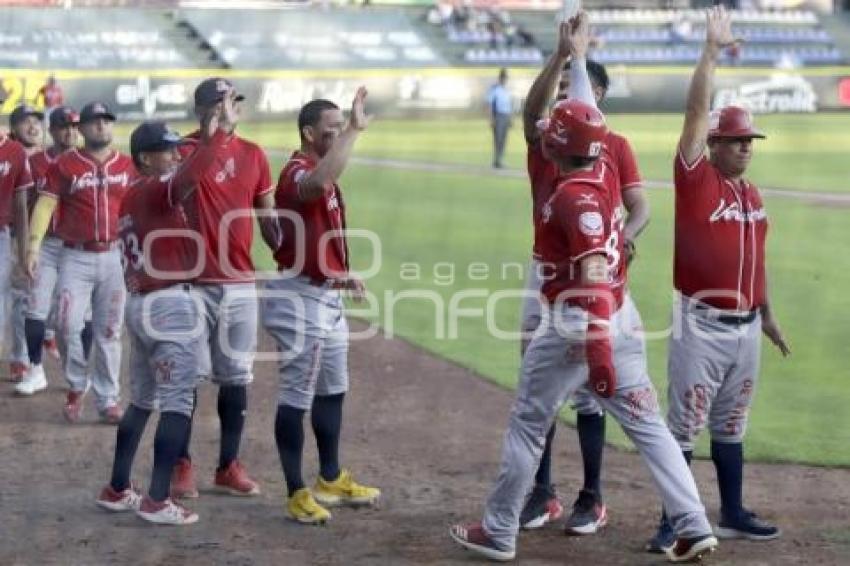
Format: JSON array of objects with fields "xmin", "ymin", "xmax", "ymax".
[{"xmin": 298, "ymin": 86, "xmax": 371, "ymax": 201}]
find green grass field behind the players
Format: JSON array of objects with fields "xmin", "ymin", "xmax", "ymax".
[{"xmin": 122, "ymin": 114, "xmax": 850, "ymax": 466}]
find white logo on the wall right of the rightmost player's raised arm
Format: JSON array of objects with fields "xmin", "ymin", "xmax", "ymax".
[{"xmin": 714, "ymin": 73, "xmax": 818, "ymax": 114}]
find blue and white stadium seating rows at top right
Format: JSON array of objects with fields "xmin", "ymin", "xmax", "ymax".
[{"xmin": 423, "ymin": 2, "xmax": 845, "ymax": 67}]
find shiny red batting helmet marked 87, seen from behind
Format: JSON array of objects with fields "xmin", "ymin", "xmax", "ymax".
[{"xmin": 538, "ymin": 99, "xmax": 608, "ymax": 157}]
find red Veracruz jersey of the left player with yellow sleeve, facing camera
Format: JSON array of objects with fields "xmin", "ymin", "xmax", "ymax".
[{"xmin": 39, "ymin": 149, "xmax": 136, "ymax": 244}]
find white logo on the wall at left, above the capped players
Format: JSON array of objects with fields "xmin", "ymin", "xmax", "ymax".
[{"xmin": 115, "ymin": 75, "xmax": 189, "ymax": 120}]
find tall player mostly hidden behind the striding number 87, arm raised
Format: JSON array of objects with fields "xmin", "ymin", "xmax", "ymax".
[{"xmin": 520, "ymin": 24, "xmax": 649, "ymax": 535}]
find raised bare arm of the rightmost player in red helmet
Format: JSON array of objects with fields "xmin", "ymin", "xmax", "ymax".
[{"xmin": 679, "ymin": 6, "xmax": 737, "ymax": 165}]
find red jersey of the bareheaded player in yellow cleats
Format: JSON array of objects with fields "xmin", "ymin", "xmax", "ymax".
[{"xmin": 274, "ymin": 151, "xmax": 348, "ymax": 281}]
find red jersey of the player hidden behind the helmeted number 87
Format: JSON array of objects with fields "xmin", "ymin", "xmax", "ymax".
[{"xmin": 527, "ymin": 130, "xmax": 641, "ymax": 257}]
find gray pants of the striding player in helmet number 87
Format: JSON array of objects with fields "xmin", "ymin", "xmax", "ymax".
[{"xmin": 483, "ymin": 297, "xmax": 711, "ymax": 549}]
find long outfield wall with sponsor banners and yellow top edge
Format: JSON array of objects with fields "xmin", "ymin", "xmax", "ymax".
[{"xmin": 0, "ymin": 66, "xmax": 850, "ymax": 120}]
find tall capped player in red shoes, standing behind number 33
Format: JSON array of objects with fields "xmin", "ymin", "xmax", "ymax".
[{"xmin": 172, "ymin": 78, "xmax": 276, "ymax": 497}]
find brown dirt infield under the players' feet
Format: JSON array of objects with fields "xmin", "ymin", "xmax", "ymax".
[{"xmin": 0, "ymin": 324, "xmax": 850, "ymax": 565}]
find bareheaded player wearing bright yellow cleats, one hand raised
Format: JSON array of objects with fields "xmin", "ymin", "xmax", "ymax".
[{"xmin": 263, "ymin": 87, "xmax": 381, "ymax": 524}]
